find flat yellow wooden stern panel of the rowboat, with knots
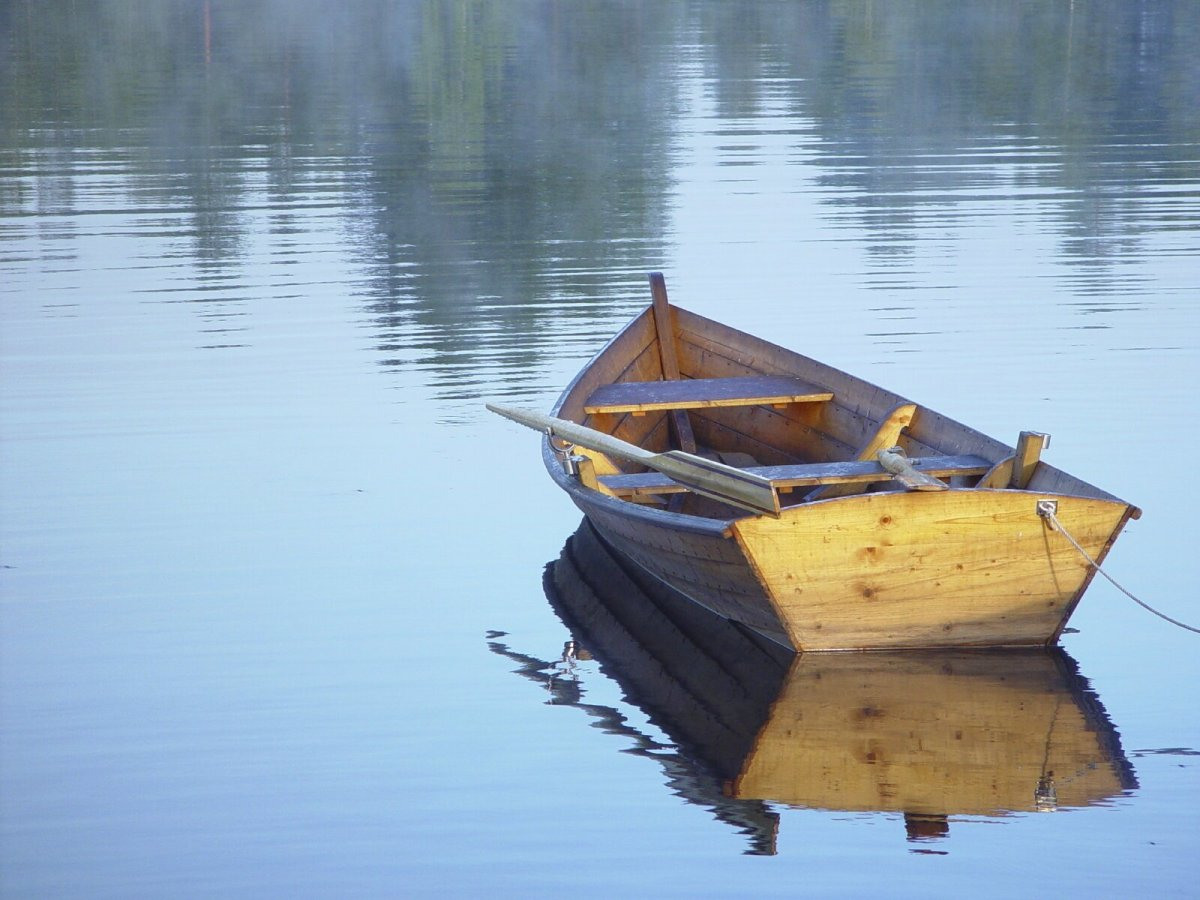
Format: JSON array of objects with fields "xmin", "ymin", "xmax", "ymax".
[{"xmin": 733, "ymin": 490, "xmax": 1127, "ymax": 649}]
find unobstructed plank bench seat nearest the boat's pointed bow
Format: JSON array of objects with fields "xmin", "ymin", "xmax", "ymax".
[{"xmin": 583, "ymin": 376, "xmax": 833, "ymax": 415}]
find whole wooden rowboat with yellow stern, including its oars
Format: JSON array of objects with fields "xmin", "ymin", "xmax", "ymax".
[{"xmin": 492, "ymin": 274, "xmax": 1140, "ymax": 650}]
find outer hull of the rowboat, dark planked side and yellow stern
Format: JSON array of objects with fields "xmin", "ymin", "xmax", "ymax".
[{"xmin": 575, "ymin": 482, "xmax": 1128, "ymax": 652}]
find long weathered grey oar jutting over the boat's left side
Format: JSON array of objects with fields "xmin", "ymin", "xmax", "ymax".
[{"xmin": 487, "ymin": 403, "xmax": 779, "ymax": 516}]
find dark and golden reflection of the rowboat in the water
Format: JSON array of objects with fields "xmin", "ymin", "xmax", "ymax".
[{"xmin": 492, "ymin": 521, "xmax": 1136, "ymax": 853}]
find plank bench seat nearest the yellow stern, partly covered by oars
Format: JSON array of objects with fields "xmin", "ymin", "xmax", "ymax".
[{"xmin": 599, "ymin": 456, "xmax": 991, "ymax": 498}]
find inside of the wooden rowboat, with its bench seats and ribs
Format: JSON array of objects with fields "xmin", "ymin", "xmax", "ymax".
[{"xmin": 557, "ymin": 276, "xmax": 1032, "ymax": 518}]
